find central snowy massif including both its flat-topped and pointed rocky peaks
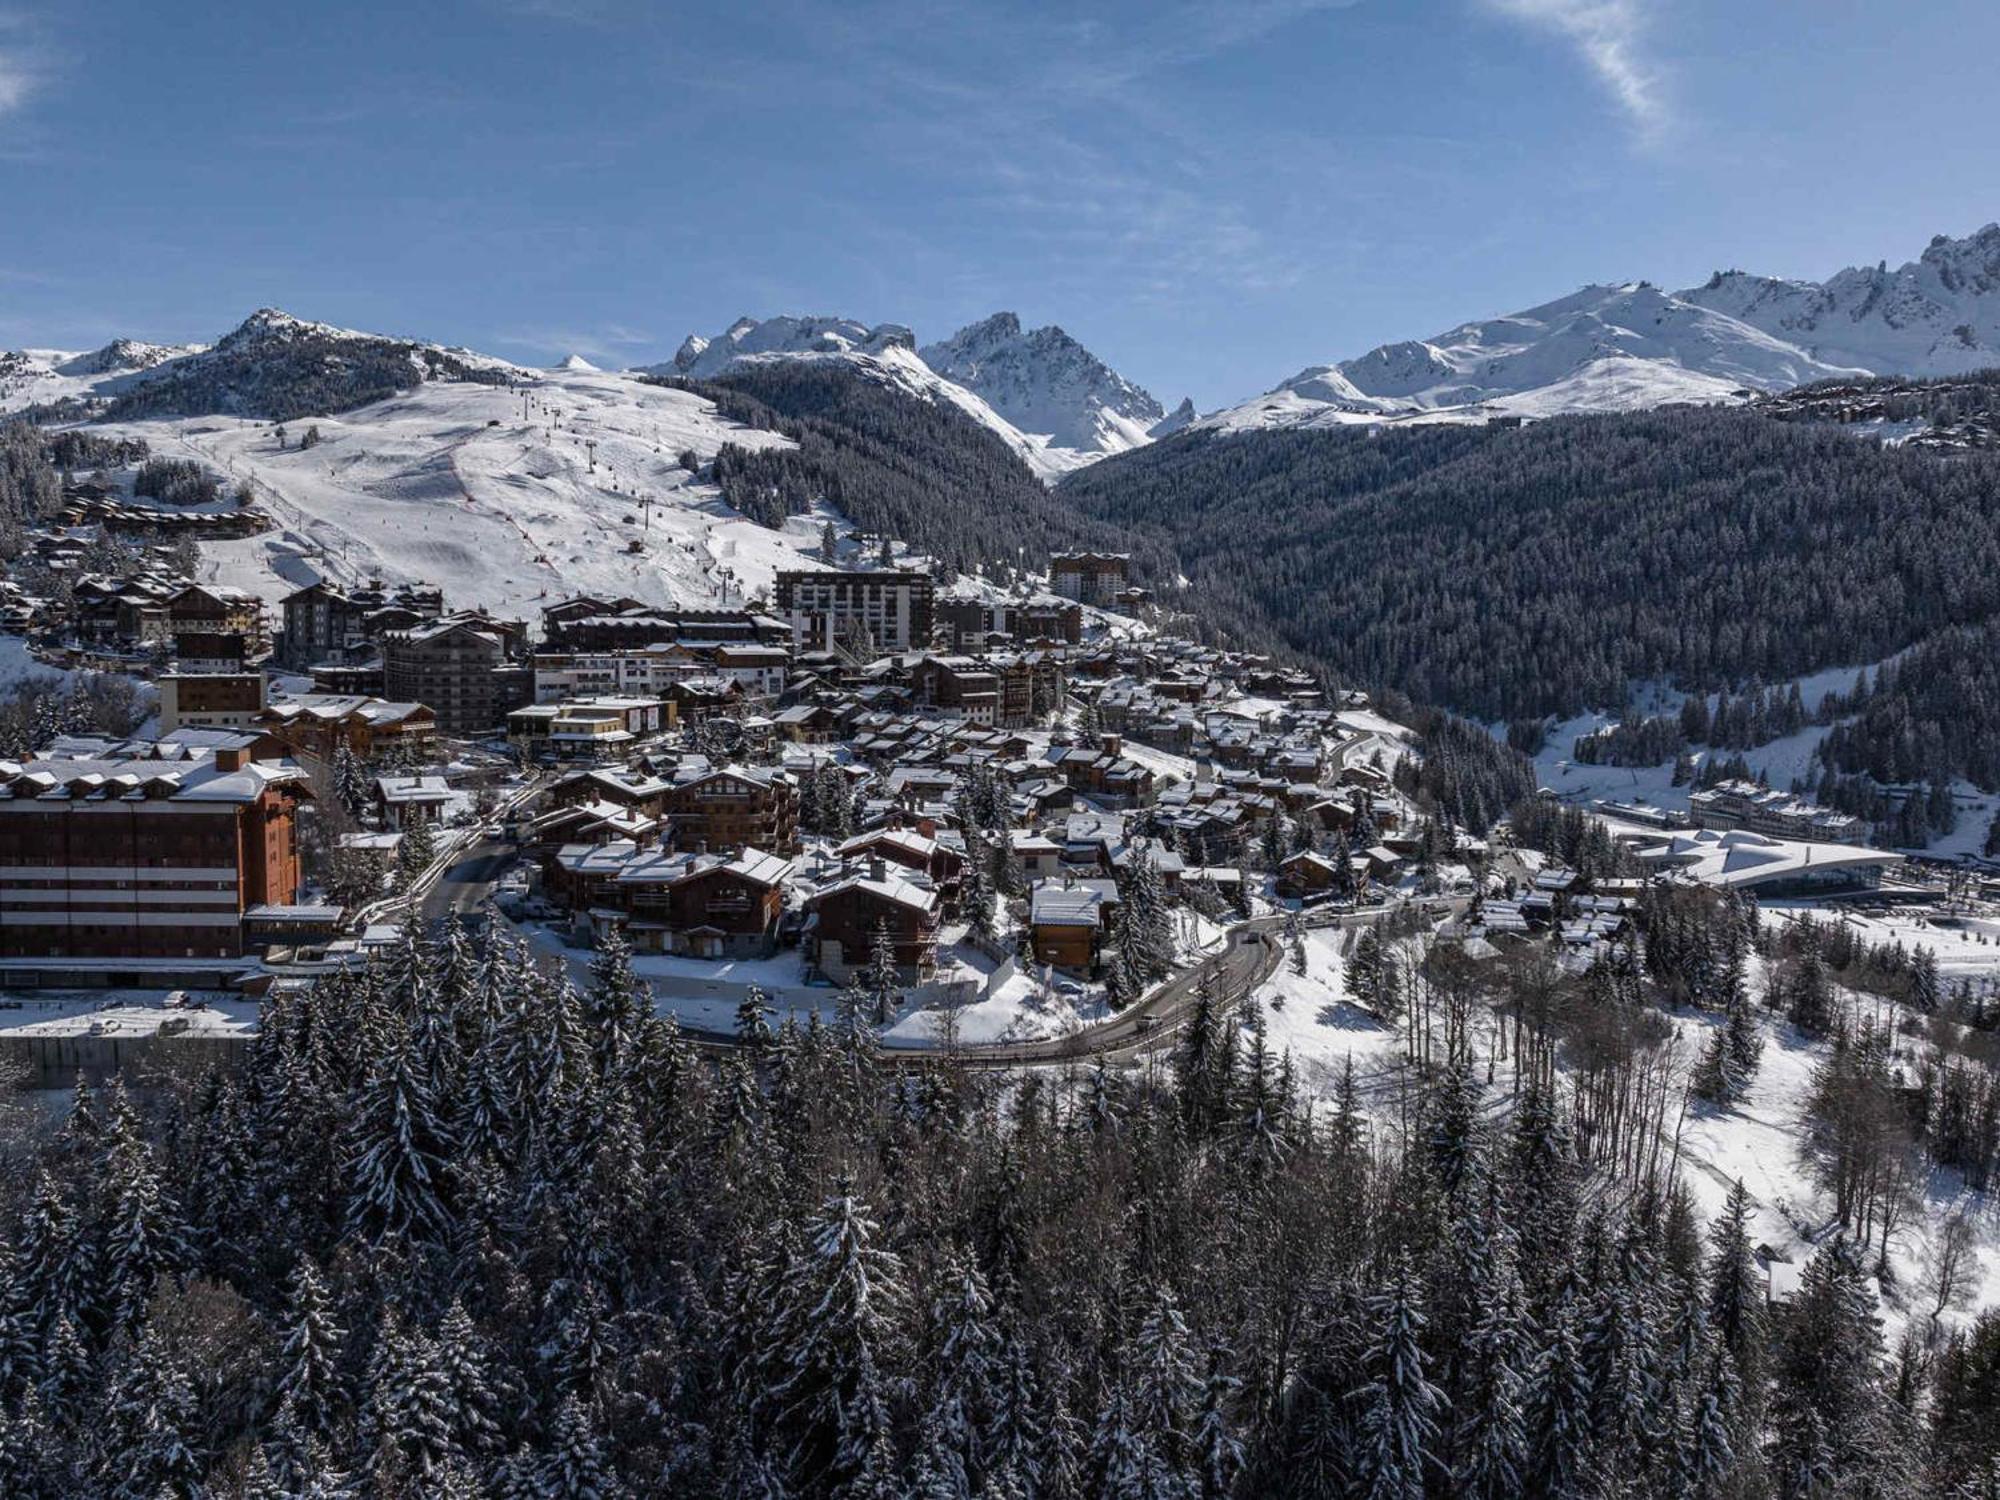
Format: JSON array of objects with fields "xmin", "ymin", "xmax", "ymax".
[{"xmin": 642, "ymin": 312, "xmax": 1162, "ymax": 480}]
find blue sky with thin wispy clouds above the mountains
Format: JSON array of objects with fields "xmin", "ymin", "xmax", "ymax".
[{"xmin": 0, "ymin": 0, "xmax": 2000, "ymax": 408}]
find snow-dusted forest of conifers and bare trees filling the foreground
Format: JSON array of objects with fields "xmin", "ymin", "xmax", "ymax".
[{"xmin": 0, "ymin": 900, "xmax": 2000, "ymax": 1500}]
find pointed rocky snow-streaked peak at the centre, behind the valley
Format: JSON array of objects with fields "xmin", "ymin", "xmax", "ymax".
[{"xmin": 918, "ymin": 312, "xmax": 1166, "ymax": 454}]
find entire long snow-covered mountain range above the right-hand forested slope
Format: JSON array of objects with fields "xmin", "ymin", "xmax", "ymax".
[{"xmin": 1202, "ymin": 224, "xmax": 2000, "ymax": 430}]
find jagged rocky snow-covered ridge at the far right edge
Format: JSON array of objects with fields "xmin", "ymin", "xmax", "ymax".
[{"xmin": 1680, "ymin": 224, "xmax": 2000, "ymax": 376}]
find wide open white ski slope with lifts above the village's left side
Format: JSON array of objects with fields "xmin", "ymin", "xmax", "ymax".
[{"xmin": 86, "ymin": 370, "xmax": 824, "ymax": 616}]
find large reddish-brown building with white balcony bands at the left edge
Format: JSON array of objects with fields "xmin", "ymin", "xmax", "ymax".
[{"xmin": 0, "ymin": 734, "xmax": 310, "ymax": 958}]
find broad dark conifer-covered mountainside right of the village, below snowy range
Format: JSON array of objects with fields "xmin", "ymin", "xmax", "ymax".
[{"xmin": 1060, "ymin": 408, "xmax": 2000, "ymax": 718}]
